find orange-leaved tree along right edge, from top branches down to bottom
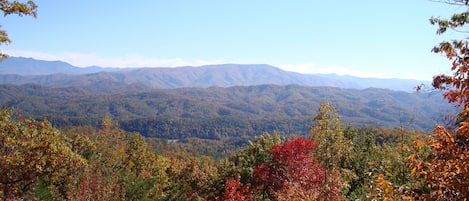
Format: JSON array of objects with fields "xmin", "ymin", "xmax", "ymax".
[{"xmin": 409, "ymin": 1, "xmax": 469, "ymax": 200}]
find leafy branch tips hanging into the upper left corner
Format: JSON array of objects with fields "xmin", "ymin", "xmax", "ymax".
[{"xmin": 0, "ymin": 0, "xmax": 37, "ymax": 59}]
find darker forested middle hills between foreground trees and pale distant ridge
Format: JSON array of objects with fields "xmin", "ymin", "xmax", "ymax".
[{"xmin": 0, "ymin": 85, "xmax": 454, "ymax": 138}]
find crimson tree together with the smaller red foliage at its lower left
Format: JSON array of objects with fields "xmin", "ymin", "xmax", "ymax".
[{"xmin": 217, "ymin": 138, "xmax": 342, "ymax": 200}]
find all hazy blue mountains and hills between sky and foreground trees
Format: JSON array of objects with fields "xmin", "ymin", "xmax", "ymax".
[{"xmin": 0, "ymin": 57, "xmax": 455, "ymax": 135}]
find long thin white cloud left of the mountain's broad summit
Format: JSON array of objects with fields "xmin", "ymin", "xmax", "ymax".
[{"xmin": 5, "ymin": 50, "xmax": 221, "ymax": 68}]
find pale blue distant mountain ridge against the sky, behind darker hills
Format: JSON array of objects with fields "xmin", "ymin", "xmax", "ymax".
[{"xmin": 0, "ymin": 57, "xmax": 426, "ymax": 91}]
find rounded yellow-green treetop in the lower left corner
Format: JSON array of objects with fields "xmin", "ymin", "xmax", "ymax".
[{"xmin": 0, "ymin": 112, "xmax": 88, "ymax": 199}]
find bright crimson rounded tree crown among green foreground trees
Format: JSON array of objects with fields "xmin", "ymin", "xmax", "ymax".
[{"xmin": 254, "ymin": 138, "xmax": 325, "ymax": 197}]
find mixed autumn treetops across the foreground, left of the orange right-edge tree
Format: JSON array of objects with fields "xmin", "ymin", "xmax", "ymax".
[{"xmin": 0, "ymin": 104, "xmax": 430, "ymax": 200}]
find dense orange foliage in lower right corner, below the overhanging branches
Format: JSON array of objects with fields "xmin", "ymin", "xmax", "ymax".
[{"xmin": 409, "ymin": 122, "xmax": 469, "ymax": 200}]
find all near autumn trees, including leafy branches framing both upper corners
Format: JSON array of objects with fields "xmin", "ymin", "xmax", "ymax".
[{"xmin": 0, "ymin": 0, "xmax": 469, "ymax": 200}]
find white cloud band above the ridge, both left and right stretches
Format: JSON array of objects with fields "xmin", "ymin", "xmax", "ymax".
[{"xmin": 5, "ymin": 50, "xmax": 428, "ymax": 79}]
